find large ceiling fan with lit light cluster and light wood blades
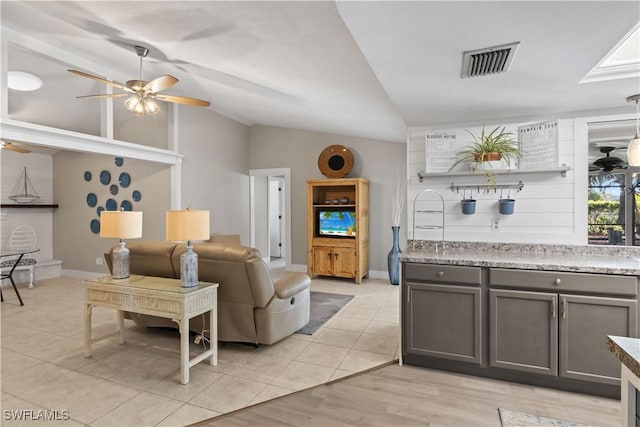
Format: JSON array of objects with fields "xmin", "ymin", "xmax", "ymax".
[{"xmin": 67, "ymin": 46, "xmax": 211, "ymax": 115}]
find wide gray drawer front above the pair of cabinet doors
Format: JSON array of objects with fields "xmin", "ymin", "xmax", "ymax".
[{"xmin": 489, "ymin": 268, "xmax": 638, "ymax": 296}]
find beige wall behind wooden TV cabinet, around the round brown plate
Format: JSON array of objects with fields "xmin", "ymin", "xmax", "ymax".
[{"xmin": 249, "ymin": 125, "xmax": 406, "ymax": 271}]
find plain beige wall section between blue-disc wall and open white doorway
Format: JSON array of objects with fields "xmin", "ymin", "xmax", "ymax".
[{"xmin": 179, "ymin": 107, "xmax": 249, "ymax": 245}]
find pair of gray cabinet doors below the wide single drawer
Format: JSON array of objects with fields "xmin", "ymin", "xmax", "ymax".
[{"xmin": 489, "ymin": 289, "xmax": 637, "ymax": 384}]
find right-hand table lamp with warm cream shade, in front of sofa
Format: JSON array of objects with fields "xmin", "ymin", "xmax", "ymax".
[{"xmin": 166, "ymin": 208, "xmax": 210, "ymax": 288}]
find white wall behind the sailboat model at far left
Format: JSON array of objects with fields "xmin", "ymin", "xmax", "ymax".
[{"xmin": 0, "ymin": 150, "xmax": 54, "ymax": 261}]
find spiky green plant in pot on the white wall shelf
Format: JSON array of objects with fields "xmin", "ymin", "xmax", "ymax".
[{"xmin": 449, "ymin": 126, "xmax": 521, "ymax": 187}]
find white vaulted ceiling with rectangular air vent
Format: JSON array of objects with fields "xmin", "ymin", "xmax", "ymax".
[{"xmin": 0, "ymin": 0, "xmax": 640, "ymax": 142}]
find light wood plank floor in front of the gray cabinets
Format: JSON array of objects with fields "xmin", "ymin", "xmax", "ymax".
[{"xmin": 194, "ymin": 364, "xmax": 620, "ymax": 427}]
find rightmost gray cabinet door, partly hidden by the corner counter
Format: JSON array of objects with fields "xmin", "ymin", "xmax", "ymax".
[{"xmin": 559, "ymin": 294, "xmax": 637, "ymax": 384}]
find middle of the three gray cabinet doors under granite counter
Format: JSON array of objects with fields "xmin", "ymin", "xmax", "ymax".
[{"xmin": 489, "ymin": 289, "xmax": 558, "ymax": 375}]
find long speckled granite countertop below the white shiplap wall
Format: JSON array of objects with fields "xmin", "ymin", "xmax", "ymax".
[{"xmin": 400, "ymin": 242, "xmax": 640, "ymax": 276}]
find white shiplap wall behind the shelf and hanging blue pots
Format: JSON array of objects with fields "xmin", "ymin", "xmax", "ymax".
[{"xmin": 407, "ymin": 119, "xmax": 586, "ymax": 244}]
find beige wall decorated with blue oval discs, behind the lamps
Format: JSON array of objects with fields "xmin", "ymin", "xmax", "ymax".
[{"xmin": 53, "ymin": 151, "xmax": 171, "ymax": 272}]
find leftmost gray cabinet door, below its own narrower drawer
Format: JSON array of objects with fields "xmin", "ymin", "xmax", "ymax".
[{"xmin": 404, "ymin": 283, "xmax": 482, "ymax": 364}]
